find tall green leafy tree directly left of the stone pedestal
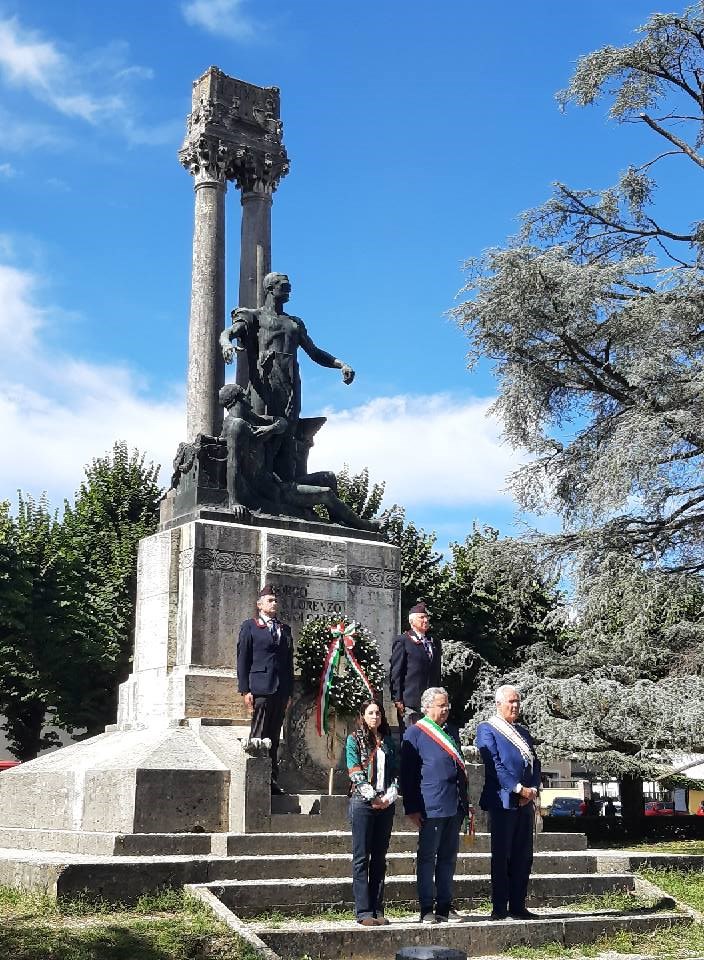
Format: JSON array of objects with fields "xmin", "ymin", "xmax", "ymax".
[{"xmin": 61, "ymin": 443, "xmax": 162, "ymax": 733}]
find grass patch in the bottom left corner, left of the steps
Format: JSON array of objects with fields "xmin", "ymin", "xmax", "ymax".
[{"xmin": 0, "ymin": 887, "xmax": 254, "ymax": 960}]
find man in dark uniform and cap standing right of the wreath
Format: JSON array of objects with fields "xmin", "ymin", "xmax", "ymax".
[{"xmin": 391, "ymin": 603, "xmax": 441, "ymax": 734}]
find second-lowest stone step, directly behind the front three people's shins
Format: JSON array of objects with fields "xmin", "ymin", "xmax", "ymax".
[{"xmin": 206, "ymin": 873, "xmax": 635, "ymax": 917}]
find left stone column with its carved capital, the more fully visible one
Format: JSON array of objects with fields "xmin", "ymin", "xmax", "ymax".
[{"xmin": 181, "ymin": 137, "xmax": 227, "ymax": 442}]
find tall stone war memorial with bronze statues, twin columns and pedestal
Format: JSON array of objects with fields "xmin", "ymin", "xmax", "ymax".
[{"xmin": 0, "ymin": 67, "xmax": 400, "ymax": 850}]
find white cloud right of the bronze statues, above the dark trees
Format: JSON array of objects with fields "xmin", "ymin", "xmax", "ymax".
[{"xmin": 310, "ymin": 394, "xmax": 521, "ymax": 508}]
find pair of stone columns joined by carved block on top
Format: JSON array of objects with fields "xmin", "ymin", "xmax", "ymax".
[{"xmin": 179, "ymin": 67, "xmax": 288, "ymax": 432}]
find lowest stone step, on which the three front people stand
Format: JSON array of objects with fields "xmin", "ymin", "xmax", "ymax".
[{"xmin": 251, "ymin": 911, "xmax": 691, "ymax": 960}]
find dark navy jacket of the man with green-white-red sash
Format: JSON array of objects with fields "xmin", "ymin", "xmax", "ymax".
[{"xmin": 401, "ymin": 723, "xmax": 469, "ymax": 817}]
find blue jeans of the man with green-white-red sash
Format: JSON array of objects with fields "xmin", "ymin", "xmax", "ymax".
[{"xmin": 416, "ymin": 812, "xmax": 464, "ymax": 917}]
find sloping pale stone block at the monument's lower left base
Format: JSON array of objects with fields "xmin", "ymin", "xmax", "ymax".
[{"xmin": 0, "ymin": 720, "xmax": 271, "ymax": 834}]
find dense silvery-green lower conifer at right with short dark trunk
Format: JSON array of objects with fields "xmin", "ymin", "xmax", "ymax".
[{"xmin": 467, "ymin": 556, "xmax": 704, "ymax": 818}]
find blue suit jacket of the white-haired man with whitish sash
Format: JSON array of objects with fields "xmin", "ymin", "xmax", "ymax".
[{"xmin": 475, "ymin": 723, "xmax": 540, "ymax": 810}]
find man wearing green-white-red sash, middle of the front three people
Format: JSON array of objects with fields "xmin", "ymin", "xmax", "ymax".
[{"xmin": 401, "ymin": 687, "xmax": 469, "ymax": 923}]
